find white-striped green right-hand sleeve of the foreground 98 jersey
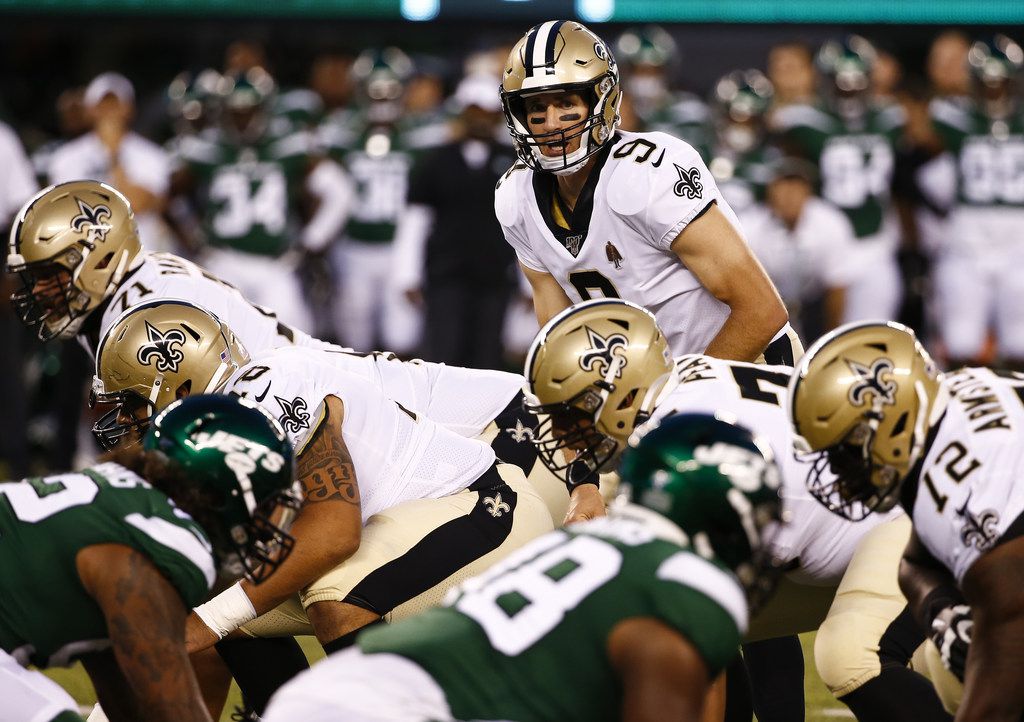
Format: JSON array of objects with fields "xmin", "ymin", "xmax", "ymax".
[{"xmin": 652, "ymin": 552, "xmax": 748, "ymax": 677}]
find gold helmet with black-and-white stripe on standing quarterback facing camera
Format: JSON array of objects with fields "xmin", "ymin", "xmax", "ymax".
[{"xmin": 501, "ymin": 20, "xmax": 623, "ymax": 174}]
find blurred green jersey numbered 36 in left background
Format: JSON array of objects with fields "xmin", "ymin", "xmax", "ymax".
[{"xmin": 319, "ymin": 106, "xmax": 449, "ymax": 243}]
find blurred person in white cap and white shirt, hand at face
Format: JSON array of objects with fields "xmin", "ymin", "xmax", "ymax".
[{"xmin": 49, "ymin": 73, "xmax": 171, "ymax": 251}]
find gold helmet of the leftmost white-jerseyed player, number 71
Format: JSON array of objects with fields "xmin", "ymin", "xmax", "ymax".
[{"xmin": 7, "ymin": 180, "xmax": 142, "ymax": 341}]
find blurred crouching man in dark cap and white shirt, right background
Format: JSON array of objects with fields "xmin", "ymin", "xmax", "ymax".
[{"xmin": 740, "ymin": 158, "xmax": 864, "ymax": 338}]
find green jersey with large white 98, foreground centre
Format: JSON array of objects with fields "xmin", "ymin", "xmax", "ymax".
[{"xmin": 357, "ymin": 518, "xmax": 748, "ymax": 722}]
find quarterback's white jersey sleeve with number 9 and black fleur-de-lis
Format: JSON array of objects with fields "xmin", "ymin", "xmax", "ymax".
[{"xmin": 607, "ymin": 133, "xmax": 719, "ymax": 250}]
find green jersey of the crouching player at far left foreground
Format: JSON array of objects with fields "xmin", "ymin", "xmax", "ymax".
[{"xmin": 0, "ymin": 463, "xmax": 214, "ymax": 667}]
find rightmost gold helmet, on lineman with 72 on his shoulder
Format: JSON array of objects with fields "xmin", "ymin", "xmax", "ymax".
[{"xmin": 790, "ymin": 322, "xmax": 942, "ymax": 521}]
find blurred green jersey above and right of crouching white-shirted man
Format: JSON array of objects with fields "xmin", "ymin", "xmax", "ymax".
[{"xmin": 775, "ymin": 99, "xmax": 906, "ymax": 239}]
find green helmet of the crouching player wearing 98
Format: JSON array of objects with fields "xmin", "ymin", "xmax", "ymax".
[{"xmin": 618, "ymin": 414, "xmax": 781, "ymax": 611}]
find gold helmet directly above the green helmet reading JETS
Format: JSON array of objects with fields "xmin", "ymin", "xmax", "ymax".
[{"xmin": 90, "ymin": 300, "xmax": 249, "ymax": 450}]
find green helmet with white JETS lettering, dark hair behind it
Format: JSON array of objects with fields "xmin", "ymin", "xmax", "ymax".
[{"xmin": 142, "ymin": 394, "xmax": 301, "ymax": 584}]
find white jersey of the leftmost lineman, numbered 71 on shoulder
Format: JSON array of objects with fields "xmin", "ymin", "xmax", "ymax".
[{"xmin": 84, "ymin": 253, "xmax": 338, "ymax": 356}]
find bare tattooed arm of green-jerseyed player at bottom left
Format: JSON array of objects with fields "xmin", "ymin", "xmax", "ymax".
[{"xmin": 76, "ymin": 544, "xmax": 210, "ymax": 722}]
